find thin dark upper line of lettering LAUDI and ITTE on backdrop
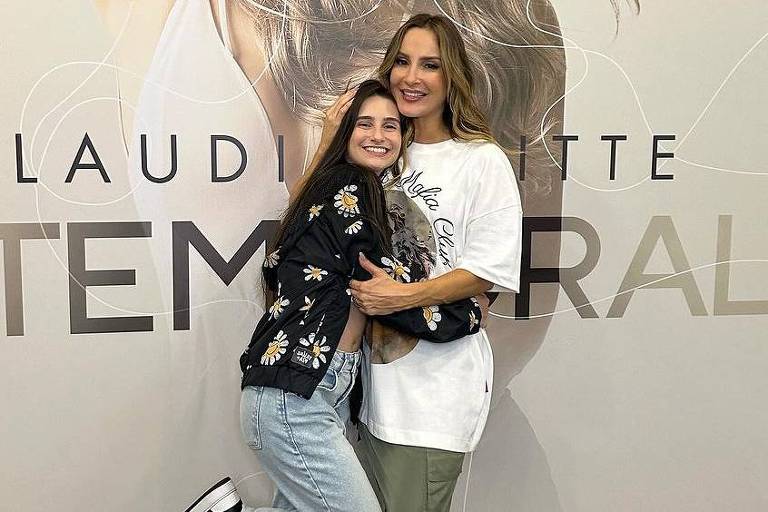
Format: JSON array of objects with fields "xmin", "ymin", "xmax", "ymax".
[{"xmin": 15, "ymin": 132, "xmax": 676, "ymax": 183}]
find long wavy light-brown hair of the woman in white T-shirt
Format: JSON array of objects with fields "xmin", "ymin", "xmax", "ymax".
[{"xmin": 378, "ymin": 14, "xmax": 498, "ymax": 148}]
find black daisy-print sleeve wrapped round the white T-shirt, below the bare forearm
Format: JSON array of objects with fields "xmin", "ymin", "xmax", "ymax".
[{"xmin": 376, "ymin": 297, "xmax": 482, "ymax": 342}]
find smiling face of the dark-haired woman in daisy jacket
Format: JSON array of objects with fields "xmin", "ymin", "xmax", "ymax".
[{"xmin": 347, "ymin": 96, "xmax": 403, "ymax": 174}]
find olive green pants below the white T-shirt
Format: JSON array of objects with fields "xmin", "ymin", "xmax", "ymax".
[{"xmin": 358, "ymin": 423, "xmax": 464, "ymax": 512}]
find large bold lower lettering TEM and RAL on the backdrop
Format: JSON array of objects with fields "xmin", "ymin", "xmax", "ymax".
[{"xmin": 0, "ymin": 215, "xmax": 768, "ymax": 336}]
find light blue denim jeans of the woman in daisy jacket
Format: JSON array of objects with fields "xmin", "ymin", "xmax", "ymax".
[{"xmin": 240, "ymin": 351, "xmax": 381, "ymax": 512}]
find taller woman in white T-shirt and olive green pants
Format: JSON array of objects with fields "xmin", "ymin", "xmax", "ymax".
[{"xmin": 344, "ymin": 14, "xmax": 522, "ymax": 512}]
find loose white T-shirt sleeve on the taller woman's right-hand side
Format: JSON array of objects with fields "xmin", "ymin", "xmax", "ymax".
[{"xmin": 455, "ymin": 145, "xmax": 523, "ymax": 292}]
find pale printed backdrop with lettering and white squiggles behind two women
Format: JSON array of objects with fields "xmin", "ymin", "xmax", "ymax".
[{"xmin": 0, "ymin": 0, "xmax": 768, "ymax": 512}]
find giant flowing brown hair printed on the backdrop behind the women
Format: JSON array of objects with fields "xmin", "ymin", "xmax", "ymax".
[{"xmin": 237, "ymin": 0, "xmax": 639, "ymax": 202}]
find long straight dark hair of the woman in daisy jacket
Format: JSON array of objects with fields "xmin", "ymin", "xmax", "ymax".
[{"xmin": 263, "ymin": 80, "xmax": 409, "ymax": 301}]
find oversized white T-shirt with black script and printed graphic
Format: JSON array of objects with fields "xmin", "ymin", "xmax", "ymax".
[{"xmin": 360, "ymin": 140, "xmax": 522, "ymax": 452}]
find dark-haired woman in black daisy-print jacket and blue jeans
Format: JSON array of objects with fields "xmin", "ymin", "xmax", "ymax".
[{"xmin": 188, "ymin": 80, "xmax": 482, "ymax": 512}]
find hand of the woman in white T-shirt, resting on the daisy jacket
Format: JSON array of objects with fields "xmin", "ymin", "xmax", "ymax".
[{"xmin": 349, "ymin": 254, "xmax": 413, "ymax": 315}]
